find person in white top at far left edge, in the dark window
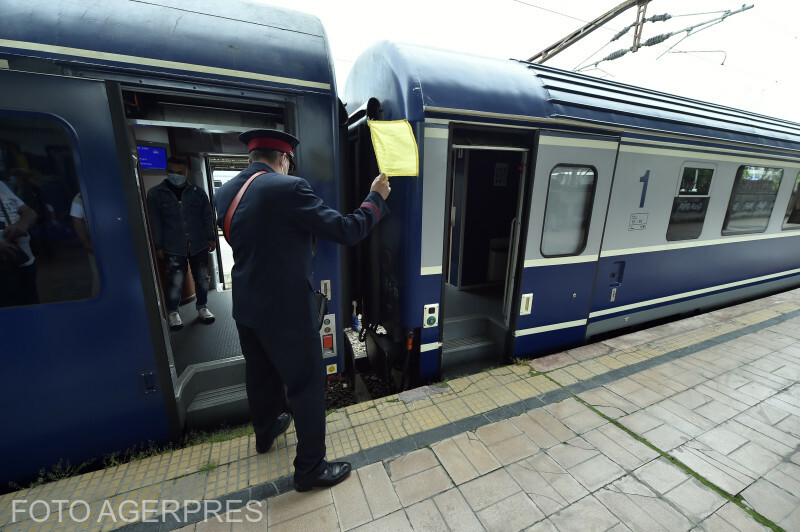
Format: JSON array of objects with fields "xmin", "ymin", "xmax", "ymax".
[{"xmin": 0, "ymin": 182, "xmax": 39, "ymax": 308}]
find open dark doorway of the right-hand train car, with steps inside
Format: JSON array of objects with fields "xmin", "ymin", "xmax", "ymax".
[{"xmin": 440, "ymin": 131, "xmax": 533, "ymax": 376}]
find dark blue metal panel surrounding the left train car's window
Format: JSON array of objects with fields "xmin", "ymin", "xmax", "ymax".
[{"xmin": 0, "ymin": 71, "xmax": 171, "ymax": 482}]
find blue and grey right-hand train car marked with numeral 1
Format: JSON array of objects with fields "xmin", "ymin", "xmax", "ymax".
[{"xmin": 342, "ymin": 42, "xmax": 800, "ymax": 381}]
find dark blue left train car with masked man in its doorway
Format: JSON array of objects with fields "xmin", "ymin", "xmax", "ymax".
[{"xmin": 0, "ymin": 0, "xmax": 350, "ymax": 486}]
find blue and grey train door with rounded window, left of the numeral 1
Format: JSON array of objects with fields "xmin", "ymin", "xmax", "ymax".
[{"xmin": 513, "ymin": 131, "xmax": 624, "ymax": 356}]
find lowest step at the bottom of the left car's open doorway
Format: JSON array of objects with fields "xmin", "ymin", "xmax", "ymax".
[{"xmin": 186, "ymin": 384, "xmax": 249, "ymax": 428}]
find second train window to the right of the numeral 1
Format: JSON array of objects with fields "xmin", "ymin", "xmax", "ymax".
[{"xmin": 722, "ymin": 166, "xmax": 783, "ymax": 235}]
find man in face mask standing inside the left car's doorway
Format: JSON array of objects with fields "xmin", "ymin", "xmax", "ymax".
[{"xmin": 147, "ymin": 157, "xmax": 217, "ymax": 330}]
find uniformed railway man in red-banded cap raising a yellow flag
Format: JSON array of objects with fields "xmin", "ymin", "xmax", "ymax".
[{"xmin": 214, "ymin": 129, "xmax": 391, "ymax": 491}]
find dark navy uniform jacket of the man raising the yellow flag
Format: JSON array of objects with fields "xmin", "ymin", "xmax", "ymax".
[{"xmin": 214, "ymin": 162, "xmax": 389, "ymax": 330}]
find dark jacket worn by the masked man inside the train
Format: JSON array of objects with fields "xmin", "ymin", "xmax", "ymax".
[{"xmin": 147, "ymin": 179, "xmax": 217, "ymax": 255}]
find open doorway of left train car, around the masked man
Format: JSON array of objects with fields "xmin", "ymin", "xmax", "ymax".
[{"xmin": 122, "ymin": 86, "xmax": 295, "ymax": 428}]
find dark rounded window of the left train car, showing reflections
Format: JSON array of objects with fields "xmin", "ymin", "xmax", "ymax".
[{"xmin": 0, "ymin": 114, "xmax": 100, "ymax": 307}]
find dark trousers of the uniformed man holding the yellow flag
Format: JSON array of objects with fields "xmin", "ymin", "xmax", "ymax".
[{"xmin": 236, "ymin": 323, "xmax": 326, "ymax": 478}]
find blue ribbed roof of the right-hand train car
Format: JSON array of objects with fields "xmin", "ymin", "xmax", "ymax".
[{"xmin": 342, "ymin": 41, "xmax": 800, "ymax": 150}]
